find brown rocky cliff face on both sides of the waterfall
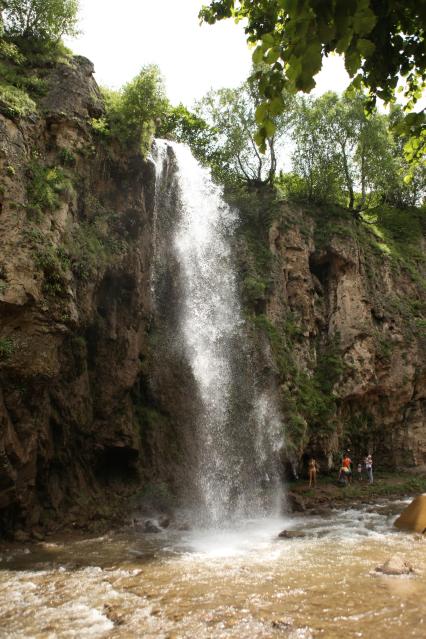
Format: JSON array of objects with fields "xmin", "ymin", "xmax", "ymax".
[{"xmin": 0, "ymin": 57, "xmax": 426, "ymax": 533}]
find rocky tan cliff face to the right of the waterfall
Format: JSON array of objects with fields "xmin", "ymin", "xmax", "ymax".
[{"xmin": 258, "ymin": 205, "xmax": 426, "ymax": 476}]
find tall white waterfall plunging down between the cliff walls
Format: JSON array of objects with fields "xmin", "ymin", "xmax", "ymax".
[{"xmin": 152, "ymin": 140, "xmax": 282, "ymax": 524}]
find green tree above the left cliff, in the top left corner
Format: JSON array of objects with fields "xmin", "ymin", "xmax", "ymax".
[{"xmin": 0, "ymin": 0, "xmax": 79, "ymax": 42}]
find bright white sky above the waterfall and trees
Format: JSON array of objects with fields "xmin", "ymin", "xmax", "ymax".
[{"xmin": 67, "ymin": 0, "xmax": 348, "ymax": 107}]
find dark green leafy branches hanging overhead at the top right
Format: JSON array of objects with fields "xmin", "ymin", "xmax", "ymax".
[{"xmin": 200, "ymin": 0, "xmax": 426, "ymax": 155}]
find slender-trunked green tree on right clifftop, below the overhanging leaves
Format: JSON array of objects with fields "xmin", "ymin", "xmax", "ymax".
[{"xmin": 292, "ymin": 92, "xmax": 393, "ymax": 210}]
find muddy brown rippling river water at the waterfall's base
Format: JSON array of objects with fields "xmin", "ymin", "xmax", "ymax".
[{"xmin": 0, "ymin": 502, "xmax": 426, "ymax": 639}]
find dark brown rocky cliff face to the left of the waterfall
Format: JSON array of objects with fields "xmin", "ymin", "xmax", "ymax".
[{"xmin": 0, "ymin": 57, "xmax": 188, "ymax": 531}]
